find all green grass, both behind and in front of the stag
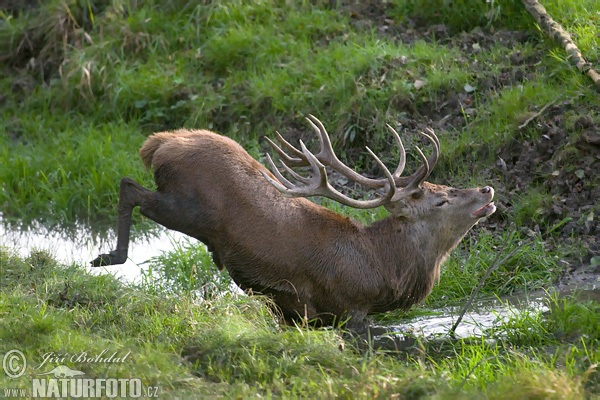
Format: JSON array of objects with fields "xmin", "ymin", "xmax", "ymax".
[{"xmin": 0, "ymin": 0, "xmax": 600, "ymax": 399}]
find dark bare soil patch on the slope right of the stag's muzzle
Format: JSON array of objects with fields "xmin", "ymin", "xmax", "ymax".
[{"xmin": 490, "ymin": 101, "xmax": 600, "ymax": 238}]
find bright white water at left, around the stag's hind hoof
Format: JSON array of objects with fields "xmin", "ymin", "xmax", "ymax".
[{"xmin": 0, "ymin": 219, "xmax": 190, "ymax": 282}]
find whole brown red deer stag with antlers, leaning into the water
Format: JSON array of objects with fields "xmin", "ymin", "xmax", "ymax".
[{"xmin": 92, "ymin": 116, "xmax": 495, "ymax": 326}]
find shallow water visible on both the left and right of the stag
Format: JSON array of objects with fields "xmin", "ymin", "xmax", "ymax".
[{"xmin": 0, "ymin": 218, "xmax": 600, "ymax": 340}]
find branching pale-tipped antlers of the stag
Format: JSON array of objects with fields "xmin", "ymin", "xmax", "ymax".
[{"xmin": 261, "ymin": 115, "xmax": 439, "ymax": 208}]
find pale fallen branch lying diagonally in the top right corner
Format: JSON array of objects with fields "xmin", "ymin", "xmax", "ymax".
[{"xmin": 521, "ymin": 0, "xmax": 600, "ymax": 88}]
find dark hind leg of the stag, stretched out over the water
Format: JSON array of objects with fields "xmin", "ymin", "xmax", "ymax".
[{"xmin": 92, "ymin": 177, "xmax": 154, "ymax": 267}]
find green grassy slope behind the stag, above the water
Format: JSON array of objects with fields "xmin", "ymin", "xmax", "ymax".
[{"xmin": 0, "ymin": 0, "xmax": 599, "ymax": 223}]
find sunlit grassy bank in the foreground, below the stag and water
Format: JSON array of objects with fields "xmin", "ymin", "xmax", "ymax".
[{"xmin": 0, "ymin": 249, "xmax": 600, "ymax": 399}]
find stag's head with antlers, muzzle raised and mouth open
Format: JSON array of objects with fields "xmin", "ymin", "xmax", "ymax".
[{"xmin": 261, "ymin": 115, "xmax": 496, "ymax": 242}]
